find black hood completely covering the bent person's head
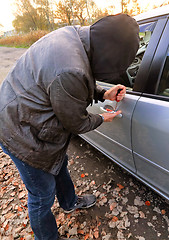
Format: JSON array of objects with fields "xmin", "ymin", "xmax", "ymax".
[{"xmin": 90, "ymin": 14, "xmax": 139, "ymax": 85}]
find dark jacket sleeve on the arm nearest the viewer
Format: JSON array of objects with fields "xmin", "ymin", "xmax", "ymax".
[{"xmin": 49, "ymin": 72, "xmax": 103, "ymax": 134}]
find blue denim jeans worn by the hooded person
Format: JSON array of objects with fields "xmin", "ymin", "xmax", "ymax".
[{"xmin": 1, "ymin": 145, "xmax": 77, "ymax": 240}]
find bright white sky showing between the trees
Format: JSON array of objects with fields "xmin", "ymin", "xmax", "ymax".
[{"xmin": 0, "ymin": 0, "xmax": 165, "ymax": 31}]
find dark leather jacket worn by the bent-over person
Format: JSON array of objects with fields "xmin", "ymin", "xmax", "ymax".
[{"xmin": 0, "ymin": 27, "xmax": 104, "ymax": 174}]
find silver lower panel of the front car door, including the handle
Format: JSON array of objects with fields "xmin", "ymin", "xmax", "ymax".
[{"xmin": 85, "ymin": 85, "xmax": 139, "ymax": 172}]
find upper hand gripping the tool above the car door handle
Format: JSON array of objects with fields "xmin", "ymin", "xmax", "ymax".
[{"xmin": 103, "ymin": 84, "xmax": 126, "ymax": 102}]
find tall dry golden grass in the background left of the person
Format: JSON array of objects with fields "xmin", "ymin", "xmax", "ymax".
[{"xmin": 0, "ymin": 31, "xmax": 49, "ymax": 48}]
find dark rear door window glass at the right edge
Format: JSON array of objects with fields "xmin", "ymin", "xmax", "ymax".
[{"xmin": 157, "ymin": 50, "xmax": 169, "ymax": 97}]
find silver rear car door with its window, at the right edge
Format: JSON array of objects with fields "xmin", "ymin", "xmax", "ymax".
[{"xmin": 132, "ymin": 17, "xmax": 169, "ymax": 200}]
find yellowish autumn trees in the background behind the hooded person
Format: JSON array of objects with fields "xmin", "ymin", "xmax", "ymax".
[{"xmin": 9, "ymin": 0, "xmax": 169, "ymax": 33}]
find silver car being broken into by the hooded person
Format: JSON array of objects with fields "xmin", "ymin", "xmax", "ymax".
[{"xmin": 82, "ymin": 6, "xmax": 169, "ymax": 201}]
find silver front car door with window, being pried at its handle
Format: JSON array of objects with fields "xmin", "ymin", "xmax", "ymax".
[{"xmin": 82, "ymin": 17, "xmax": 165, "ymax": 173}]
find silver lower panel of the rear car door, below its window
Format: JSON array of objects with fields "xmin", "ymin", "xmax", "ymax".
[{"xmin": 132, "ymin": 97, "xmax": 169, "ymax": 198}]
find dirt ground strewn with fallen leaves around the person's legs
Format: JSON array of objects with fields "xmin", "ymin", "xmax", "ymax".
[{"xmin": 0, "ymin": 48, "xmax": 169, "ymax": 240}]
